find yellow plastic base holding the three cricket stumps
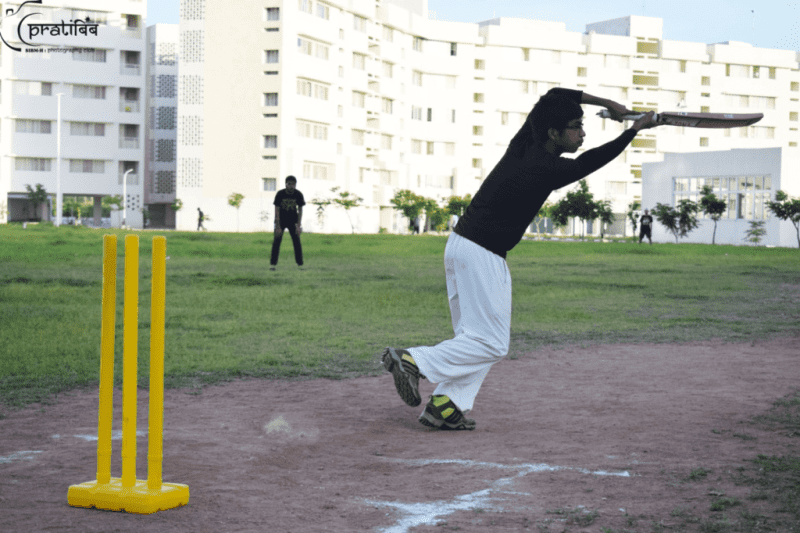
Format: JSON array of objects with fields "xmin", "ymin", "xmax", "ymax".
[{"xmin": 67, "ymin": 477, "xmax": 189, "ymax": 514}]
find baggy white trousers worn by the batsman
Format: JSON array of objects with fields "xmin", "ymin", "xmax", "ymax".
[{"xmin": 408, "ymin": 232, "xmax": 511, "ymax": 412}]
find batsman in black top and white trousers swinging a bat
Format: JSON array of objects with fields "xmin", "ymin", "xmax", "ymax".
[{"xmin": 381, "ymin": 89, "xmax": 656, "ymax": 429}]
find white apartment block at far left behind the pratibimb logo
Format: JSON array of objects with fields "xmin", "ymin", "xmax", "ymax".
[{"xmin": 0, "ymin": 0, "xmax": 146, "ymax": 227}]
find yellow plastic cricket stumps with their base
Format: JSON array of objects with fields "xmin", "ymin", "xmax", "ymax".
[{"xmin": 67, "ymin": 235, "xmax": 189, "ymax": 514}]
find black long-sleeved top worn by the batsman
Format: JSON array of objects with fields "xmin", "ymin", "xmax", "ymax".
[{"xmin": 455, "ymin": 88, "xmax": 636, "ymax": 258}]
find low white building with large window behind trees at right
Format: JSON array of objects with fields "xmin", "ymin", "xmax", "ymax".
[{"xmin": 642, "ymin": 148, "xmax": 800, "ymax": 248}]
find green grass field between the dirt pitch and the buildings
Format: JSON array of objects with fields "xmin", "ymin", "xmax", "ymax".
[{"xmin": 0, "ymin": 225, "xmax": 800, "ymax": 407}]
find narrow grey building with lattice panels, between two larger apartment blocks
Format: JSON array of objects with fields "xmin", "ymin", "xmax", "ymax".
[{"xmin": 144, "ymin": 24, "xmax": 178, "ymax": 228}]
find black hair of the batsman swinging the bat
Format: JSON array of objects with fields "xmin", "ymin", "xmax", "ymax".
[{"xmin": 509, "ymin": 92, "xmax": 583, "ymax": 157}]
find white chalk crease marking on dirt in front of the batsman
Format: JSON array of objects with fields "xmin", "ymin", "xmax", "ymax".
[{"xmin": 365, "ymin": 459, "xmax": 631, "ymax": 533}]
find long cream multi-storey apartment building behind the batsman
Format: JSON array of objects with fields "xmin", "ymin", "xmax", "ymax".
[{"xmin": 176, "ymin": 0, "xmax": 800, "ymax": 233}]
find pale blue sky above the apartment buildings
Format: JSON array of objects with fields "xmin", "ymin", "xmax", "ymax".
[{"xmin": 147, "ymin": 0, "xmax": 800, "ymax": 51}]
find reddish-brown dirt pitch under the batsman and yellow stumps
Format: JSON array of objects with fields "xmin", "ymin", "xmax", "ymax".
[{"xmin": 0, "ymin": 339, "xmax": 800, "ymax": 533}]
